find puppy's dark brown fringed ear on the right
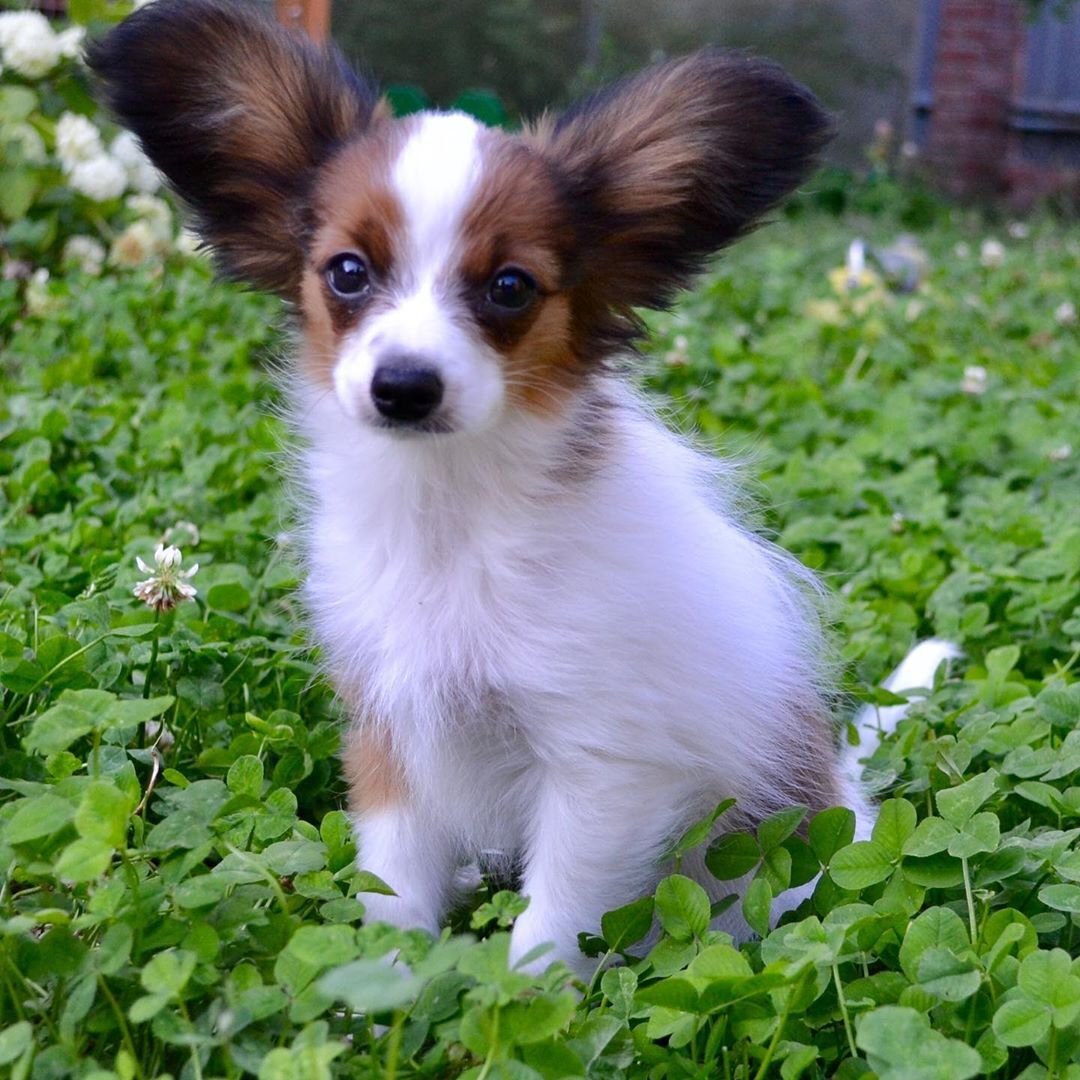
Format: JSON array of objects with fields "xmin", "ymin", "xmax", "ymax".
[{"xmin": 529, "ymin": 49, "xmax": 831, "ymax": 349}]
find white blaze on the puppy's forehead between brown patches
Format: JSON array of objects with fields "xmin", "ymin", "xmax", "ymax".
[{"xmin": 393, "ymin": 112, "xmax": 481, "ymax": 286}]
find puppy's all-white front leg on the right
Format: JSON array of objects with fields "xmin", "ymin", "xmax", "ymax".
[{"xmin": 510, "ymin": 762, "xmax": 688, "ymax": 977}]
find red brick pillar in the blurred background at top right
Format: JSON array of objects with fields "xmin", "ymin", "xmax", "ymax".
[{"xmin": 927, "ymin": 0, "xmax": 1024, "ymax": 195}]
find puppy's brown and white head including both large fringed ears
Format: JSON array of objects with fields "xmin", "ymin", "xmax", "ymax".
[{"xmin": 89, "ymin": 0, "xmax": 828, "ymax": 432}]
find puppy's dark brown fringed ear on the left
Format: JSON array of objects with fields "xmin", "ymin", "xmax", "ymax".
[{"xmin": 87, "ymin": 0, "xmax": 377, "ymax": 296}]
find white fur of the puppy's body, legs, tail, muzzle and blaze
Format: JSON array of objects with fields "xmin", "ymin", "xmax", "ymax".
[{"xmin": 294, "ymin": 113, "xmax": 959, "ymax": 970}]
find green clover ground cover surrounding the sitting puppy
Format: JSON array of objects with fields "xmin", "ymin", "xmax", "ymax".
[{"xmin": 0, "ymin": 198, "xmax": 1080, "ymax": 1080}]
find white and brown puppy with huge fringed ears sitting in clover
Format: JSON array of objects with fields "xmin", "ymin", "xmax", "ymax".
[{"xmin": 89, "ymin": 0, "xmax": 949, "ymax": 973}]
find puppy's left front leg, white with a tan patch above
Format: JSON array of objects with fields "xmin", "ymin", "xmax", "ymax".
[{"xmin": 343, "ymin": 728, "xmax": 456, "ymax": 934}]
